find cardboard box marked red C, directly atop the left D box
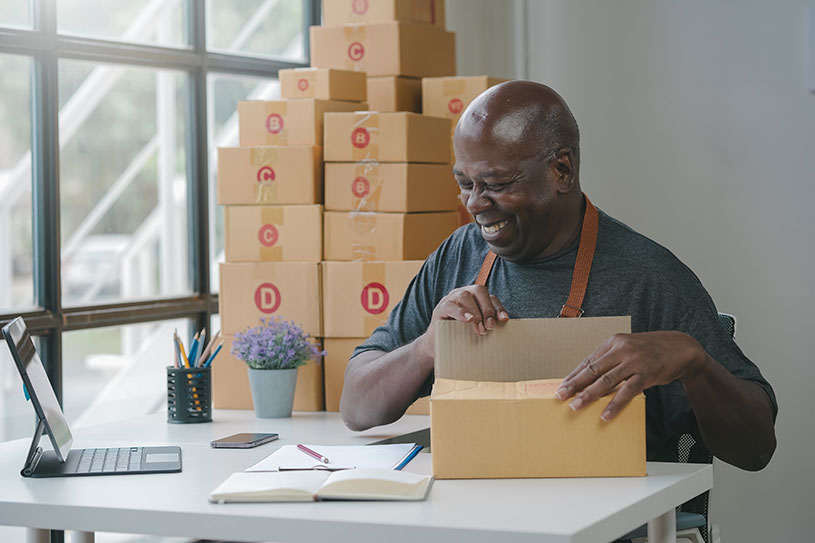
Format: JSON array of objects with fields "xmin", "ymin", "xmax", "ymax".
[{"xmin": 224, "ymin": 205, "xmax": 323, "ymax": 262}]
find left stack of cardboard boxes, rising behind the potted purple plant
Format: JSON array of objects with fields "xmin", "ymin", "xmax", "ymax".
[{"xmin": 213, "ymin": 69, "xmax": 367, "ymax": 411}]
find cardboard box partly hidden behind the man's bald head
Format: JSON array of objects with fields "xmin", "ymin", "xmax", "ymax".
[{"xmin": 422, "ymin": 75, "xmax": 506, "ymax": 133}]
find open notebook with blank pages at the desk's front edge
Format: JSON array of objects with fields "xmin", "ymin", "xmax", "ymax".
[{"xmin": 209, "ymin": 468, "xmax": 433, "ymax": 503}]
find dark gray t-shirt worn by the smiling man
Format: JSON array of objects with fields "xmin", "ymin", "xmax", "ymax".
[{"xmin": 354, "ymin": 211, "xmax": 778, "ymax": 461}]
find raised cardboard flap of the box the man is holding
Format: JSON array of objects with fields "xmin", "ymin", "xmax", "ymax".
[{"xmin": 435, "ymin": 316, "xmax": 631, "ymax": 382}]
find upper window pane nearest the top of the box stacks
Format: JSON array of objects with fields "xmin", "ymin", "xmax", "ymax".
[{"xmin": 206, "ymin": 0, "xmax": 306, "ymax": 61}]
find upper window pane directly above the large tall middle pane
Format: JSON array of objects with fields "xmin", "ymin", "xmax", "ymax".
[{"xmin": 56, "ymin": 0, "xmax": 189, "ymax": 47}]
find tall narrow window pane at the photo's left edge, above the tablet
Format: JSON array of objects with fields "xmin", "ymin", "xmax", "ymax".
[{"xmin": 0, "ymin": 54, "xmax": 34, "ymax": 313}]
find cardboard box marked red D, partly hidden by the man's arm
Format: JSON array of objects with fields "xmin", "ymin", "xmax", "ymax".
[{"xmin": 323, "ymin": 260, "xmax": 423, "ymax": 338}]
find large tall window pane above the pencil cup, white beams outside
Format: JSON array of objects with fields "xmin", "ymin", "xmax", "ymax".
[{"xmin": 59, "ymin": 61, "xmax": 190, "ymax": 305}]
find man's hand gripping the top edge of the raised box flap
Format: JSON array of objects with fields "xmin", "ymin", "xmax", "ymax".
[{"xmin": 419, "ymin": 285, "xmax": 509, "ymax": 359}]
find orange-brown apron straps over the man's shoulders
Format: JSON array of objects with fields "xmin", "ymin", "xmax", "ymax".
[{"xmin": 475, "ymin": 194, "xmax": 600, "ymax": 317}]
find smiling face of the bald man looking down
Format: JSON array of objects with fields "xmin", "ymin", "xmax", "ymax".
[{"xmin": 453, "ymin": 82, "xmax": 582, "ymax": 261}]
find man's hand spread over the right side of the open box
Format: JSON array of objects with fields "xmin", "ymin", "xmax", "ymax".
[{"xmin": 557, "ymin": 332, "xmax": 709, "ymax": 420}]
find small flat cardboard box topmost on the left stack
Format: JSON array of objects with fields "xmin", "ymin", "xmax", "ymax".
[{"xmin": 277, "ymin": 68, "xmax": 368, "ymax": 102}]
